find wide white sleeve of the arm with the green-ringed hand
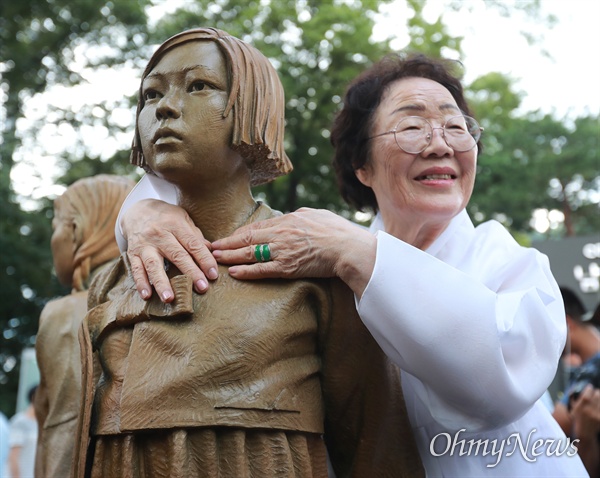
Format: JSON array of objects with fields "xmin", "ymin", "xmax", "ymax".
[{"xmin": 358, "ymin": 231, "xmax": 566, "ymax": 431}]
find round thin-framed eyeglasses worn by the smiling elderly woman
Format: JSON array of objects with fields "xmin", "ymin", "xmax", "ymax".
[{"xmin": 367, "ymin": 115, "xmax": 483, "ymax": 154}]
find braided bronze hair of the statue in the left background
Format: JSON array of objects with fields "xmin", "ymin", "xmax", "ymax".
[{"xmin": 54, "ymin": 174, "xmax": 135, "ymax": 291}]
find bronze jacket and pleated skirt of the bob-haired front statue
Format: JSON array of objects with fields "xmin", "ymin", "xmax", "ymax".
[{"xmin": 75, "ymin": 205, "xmax": 422, "ymax": 478}]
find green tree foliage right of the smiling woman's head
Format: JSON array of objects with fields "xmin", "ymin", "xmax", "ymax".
[{"xmin": 468, "ymin": 73, "xmax": 600, "ymax": 236}]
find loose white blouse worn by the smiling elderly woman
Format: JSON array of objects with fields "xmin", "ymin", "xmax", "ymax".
[{"xmin": 357, "ymin": 211, "xmax": 588, "ymax": 478}]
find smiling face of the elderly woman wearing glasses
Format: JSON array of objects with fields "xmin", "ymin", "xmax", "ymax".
[{"xmin": 356, "ymin": 78, "xmax": 477, "ymax": 235}]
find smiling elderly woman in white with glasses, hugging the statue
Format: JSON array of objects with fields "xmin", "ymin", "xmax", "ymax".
[{"xmin": 123, "ymin": 56, "xmax": 587, "ymax": 478}]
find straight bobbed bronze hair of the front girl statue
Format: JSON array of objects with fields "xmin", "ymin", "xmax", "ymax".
[{"xmin": 131, "ymin": 28, "xmax": 292, "ymax": 186}]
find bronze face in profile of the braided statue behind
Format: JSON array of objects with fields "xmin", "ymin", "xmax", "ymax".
[{"xmin": 50, "ymin": 210, "xmax": 77, "ymax": 286}]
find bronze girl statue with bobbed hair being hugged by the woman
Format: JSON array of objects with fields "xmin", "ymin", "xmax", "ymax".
[{"xmin": 75, "ymin": 28, "xmax": 422, "ymax": 478}]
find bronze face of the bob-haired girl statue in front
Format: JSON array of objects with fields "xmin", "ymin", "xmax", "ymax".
[{"xmin": 138, "ymin": 41, "xmax": 245, "ymax": 184}]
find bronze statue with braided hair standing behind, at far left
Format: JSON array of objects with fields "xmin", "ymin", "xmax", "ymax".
[{"xmin": 34, "ymin": 174, "xmax": 134, "ymax": 477}]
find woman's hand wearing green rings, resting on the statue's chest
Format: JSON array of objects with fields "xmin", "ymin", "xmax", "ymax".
[{"xmin": 212, "ymin": 208, "xmax": 377, "ymax": 296}]
